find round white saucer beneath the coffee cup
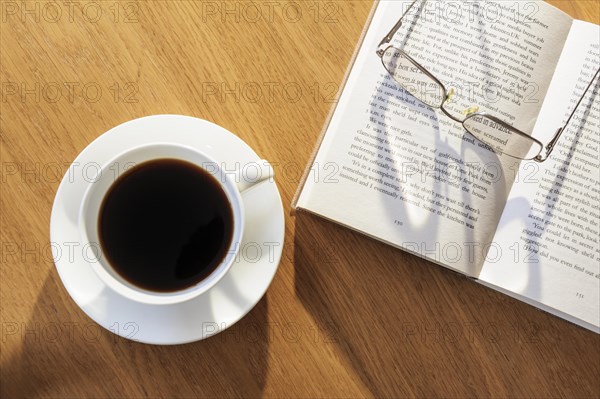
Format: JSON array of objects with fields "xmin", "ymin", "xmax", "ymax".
[{"xmin": 50, "ymin": 115, "xmax": 285, "ymax": 345}]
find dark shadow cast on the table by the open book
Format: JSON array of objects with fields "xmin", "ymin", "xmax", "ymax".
[{"xmin": 294, "ymin": 212, "xmax": 597, "ymax": 397}]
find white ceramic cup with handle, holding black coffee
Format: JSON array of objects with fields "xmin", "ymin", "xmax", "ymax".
[{"xmin": 79, "ymin": 143, "xmax": 273, "ymax": 305}]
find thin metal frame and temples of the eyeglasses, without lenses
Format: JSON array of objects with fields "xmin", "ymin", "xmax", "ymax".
[{"xmin": 377, "ymin": 0, "xmax": 600, "ymax": 162}]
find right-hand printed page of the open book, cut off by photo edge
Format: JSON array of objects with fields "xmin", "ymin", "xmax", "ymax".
[{"xmin": 480, "ymin": 21, "xmax": 600, "ymax": 332}]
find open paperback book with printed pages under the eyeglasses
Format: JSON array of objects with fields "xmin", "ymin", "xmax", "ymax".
[{"xmin": 294, "ymin": 1, "xmax": 600, "ymax": 332}]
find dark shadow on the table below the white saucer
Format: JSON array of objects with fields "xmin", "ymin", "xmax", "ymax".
[{"xmin": 0, "ymin": 273, "xmax": 269, "ymax": 398}]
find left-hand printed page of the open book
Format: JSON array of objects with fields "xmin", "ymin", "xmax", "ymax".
[{"xmin": 297, "ymin": 1, "xmax": 572, "ymax": 276}]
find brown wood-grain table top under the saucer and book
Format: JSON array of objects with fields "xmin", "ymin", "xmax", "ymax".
[{"xmin": 0, "ymin": 0, "xmax": 600, "ymax": 398}]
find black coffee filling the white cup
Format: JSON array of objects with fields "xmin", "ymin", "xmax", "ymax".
[{"xmin": 99, "ymin": 159, "xmax": 233, "ymax": 292}]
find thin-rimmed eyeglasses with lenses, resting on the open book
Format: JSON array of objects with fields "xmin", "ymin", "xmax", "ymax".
[{"xmin": 377, "ymin": 0, "xmax": 600, "ymax": 162}]
